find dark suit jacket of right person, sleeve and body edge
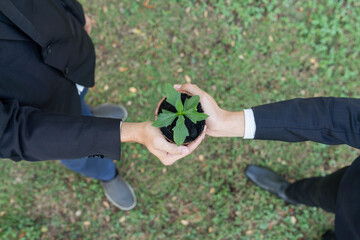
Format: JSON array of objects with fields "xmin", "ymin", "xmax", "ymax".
[{"xmin": 253, "ymin": 98, "xmax": 360, "ymax": 240}]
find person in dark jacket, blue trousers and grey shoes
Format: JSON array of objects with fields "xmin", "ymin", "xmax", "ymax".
[{"xmin": 0, "ymin": 0, "xmax": 204, "ymax": 210}]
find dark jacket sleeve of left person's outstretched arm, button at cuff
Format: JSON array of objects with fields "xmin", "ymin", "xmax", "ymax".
[{"xmin": 0, "ymin": 100, "xmax": 120, "ymax": 161}]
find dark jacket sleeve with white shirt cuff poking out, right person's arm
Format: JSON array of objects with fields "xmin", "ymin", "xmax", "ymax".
[{"xmin": 253, "ymin": 97, "xmax": 360, "ymax": 148}]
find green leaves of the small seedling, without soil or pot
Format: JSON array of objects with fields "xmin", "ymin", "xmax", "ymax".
[{"xmin": 152, "ymin": 83, "xmax": 209, "ymax": 146}]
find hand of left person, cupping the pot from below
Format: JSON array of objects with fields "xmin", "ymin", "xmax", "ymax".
[{"xmin": 121, "ymin": 122, "xmax": 206, "ymax": 165}]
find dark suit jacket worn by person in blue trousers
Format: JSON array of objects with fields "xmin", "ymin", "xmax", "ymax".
[{"xmin": 0, "ymin": 0, "xmax": 120, "ymax": 161}]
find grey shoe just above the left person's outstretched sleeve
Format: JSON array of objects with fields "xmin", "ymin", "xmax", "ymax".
[{"xmin": 91, "ymin": 103, "xmax": 128, "ymax": 122}]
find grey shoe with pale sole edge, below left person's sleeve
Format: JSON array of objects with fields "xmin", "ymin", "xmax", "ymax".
[{"xmin": 101, "ymin": 174, "xmax": 136, "ymax": 211}]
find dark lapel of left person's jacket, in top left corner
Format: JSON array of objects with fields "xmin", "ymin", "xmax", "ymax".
[{"xmin": 0, "ymin": 0, "xmax": 45, "ymax": 47}]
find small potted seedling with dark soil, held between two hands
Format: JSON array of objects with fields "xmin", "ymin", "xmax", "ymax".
[{"xmin": 152, "ymin": 83, "xmax": 209, "ymax": 146}]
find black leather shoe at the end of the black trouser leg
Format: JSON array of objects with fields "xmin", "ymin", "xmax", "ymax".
[{"xmin": 245, "ymin": 165, "xmax": 298, "ymax": 205}]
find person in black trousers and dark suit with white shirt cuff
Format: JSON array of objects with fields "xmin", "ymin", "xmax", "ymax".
[{"xmin": 174, "ymin": 84, "xmax": 360, "ymax": 240}]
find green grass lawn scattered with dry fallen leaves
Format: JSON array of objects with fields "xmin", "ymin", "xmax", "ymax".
[{"xmin": 0, "ymin": 0, "xmax": 360, "ymax": 240}]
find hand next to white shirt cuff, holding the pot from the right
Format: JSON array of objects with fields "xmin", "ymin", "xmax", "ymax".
[{"xmin": 174, "ymin": 83, "xmax": 245, "ymax": 137}]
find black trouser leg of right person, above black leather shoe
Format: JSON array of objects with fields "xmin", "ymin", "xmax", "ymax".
[{"xmin": 285, "ymin": 167, "xmax": 348, "ymax": 213}]
